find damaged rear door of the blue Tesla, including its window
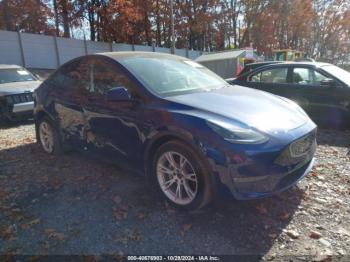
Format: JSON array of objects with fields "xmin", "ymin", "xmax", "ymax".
[{"xmin": 45, "ymin": 58, "xmax": 89, "ymax": 149}]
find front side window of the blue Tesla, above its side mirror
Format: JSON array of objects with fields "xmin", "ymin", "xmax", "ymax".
[{"xmin": 88, "ymin": 58, "xmax": 135, "ymax": 95}]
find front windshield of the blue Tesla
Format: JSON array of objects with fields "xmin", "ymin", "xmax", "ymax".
[{"xmin": 120, "ymin": 56, "xmax": 227, "ymax": 97}]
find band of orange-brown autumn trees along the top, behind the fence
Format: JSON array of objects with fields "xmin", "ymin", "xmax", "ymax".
[{"xmin": 0, "ymin": 0, "xmax": 350, "ymax": 60}]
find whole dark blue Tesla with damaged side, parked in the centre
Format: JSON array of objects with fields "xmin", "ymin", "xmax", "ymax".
[{"xmin": 34, "ymin": 52, "xmax": 316, "ymax": 209}]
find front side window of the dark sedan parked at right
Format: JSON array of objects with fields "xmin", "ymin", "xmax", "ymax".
[{"xmin": 292, "ymin": 67, "xmax": 327, "ymax": 86}]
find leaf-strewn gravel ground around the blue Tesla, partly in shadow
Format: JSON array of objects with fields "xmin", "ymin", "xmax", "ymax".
[{"xmin": 0, "ymin": 122, "xmax": 350, "ymax": 260}]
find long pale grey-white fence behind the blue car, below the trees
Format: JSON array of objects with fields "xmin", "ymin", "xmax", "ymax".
[{"xmin": 0, "ymin": 30, "xmax": 205, "ymax": 69}]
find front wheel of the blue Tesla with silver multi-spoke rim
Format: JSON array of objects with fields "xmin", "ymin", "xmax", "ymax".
[{"xmin": 151, "ymin": 141, "xmax": 213, "ymax": 210}]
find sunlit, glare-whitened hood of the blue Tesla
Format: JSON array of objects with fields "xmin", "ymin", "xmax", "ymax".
[{"xmin": 166, "ymin": 85, "xmax": 309, "ymax": 132}]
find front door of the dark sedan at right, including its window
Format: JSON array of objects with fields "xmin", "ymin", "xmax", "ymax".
[{"xmin": 290, "ymin": 66, "xmax": 349, "ymax": 127}]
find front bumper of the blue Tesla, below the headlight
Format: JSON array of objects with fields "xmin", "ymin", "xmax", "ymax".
[{"xmin": 202, "ymin": 124, "xmax": 317, "ymax": 200}]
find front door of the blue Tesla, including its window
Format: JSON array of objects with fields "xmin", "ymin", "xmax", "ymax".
[{"xmin": 84, "ymin": 57, "xmax": 145, "ymax": 165}]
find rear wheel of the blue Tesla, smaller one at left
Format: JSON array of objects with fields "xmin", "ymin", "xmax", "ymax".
[{"xmin": 37, "ymin": 117, "xmax": 63, "ymax": 155}]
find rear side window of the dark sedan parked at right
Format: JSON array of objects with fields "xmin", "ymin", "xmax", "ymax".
[{"xmin": 248, "ymin": 67, "xmax": 288, "ymax": 84}]
